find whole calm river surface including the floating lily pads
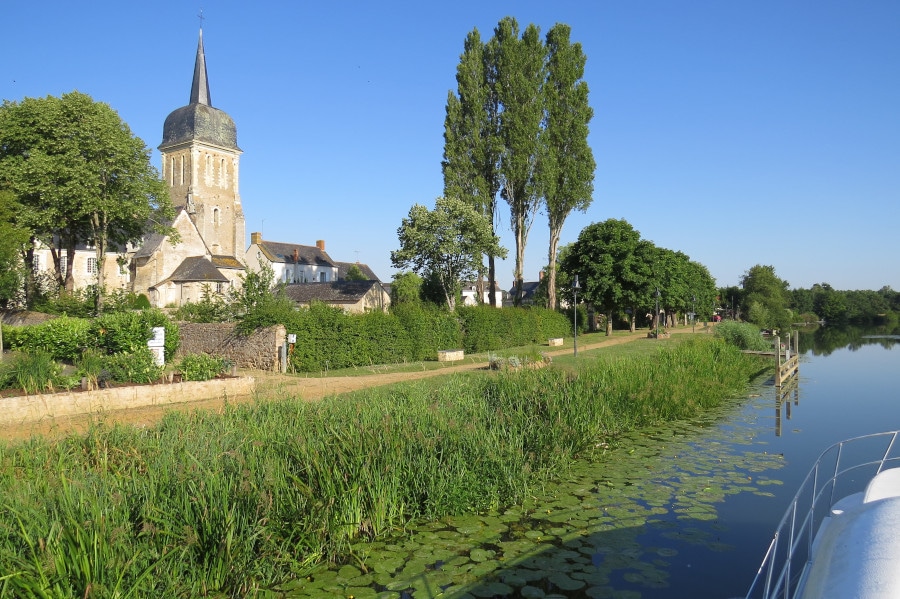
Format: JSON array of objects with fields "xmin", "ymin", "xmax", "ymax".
[{"xmin": 283, "ymin": 329, "xmax": 900, "ymax": 599}]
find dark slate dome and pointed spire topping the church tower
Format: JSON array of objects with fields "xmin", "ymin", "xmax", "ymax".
[{"xmin": 159, "ymin": 30, "xmax": 240, "ymax": 151}]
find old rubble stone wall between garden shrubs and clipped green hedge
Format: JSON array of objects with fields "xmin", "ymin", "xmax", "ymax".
[{"xmin": 175, "ymin": 322, "xmax": 285, "ymax": 371}]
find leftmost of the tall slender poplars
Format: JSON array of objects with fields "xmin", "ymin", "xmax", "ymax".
[{"xmin": 441, "ymin": 29, "xmax": 502, "ymax": 305}]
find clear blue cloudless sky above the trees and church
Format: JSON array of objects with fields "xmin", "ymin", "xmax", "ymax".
[{"xmin": 0, "ymin": 0, "xmax": 900, "ymax": 290}]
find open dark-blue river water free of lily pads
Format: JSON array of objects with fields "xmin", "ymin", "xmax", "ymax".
[{"xmin": 632, "ymin": 331, "xmax": 900, "ymax": 598}]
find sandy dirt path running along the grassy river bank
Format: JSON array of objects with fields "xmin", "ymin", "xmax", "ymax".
[{"xmin": 0, "ymin": 326, "xmax": 703, "ymax": 440}]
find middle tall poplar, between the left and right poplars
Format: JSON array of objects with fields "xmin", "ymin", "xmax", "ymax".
[{"xmin": 487, "ymin": 17, "xmax": 546, "ymax": 305}]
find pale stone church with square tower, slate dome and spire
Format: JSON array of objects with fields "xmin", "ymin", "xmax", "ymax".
[{"xmin": 131, "ymin": 30, "xmax": 246, "ymax": 307}]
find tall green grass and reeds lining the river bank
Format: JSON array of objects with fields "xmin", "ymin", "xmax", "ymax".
[{"xmin": 0, "ymin": 341, "xmax": 760, "ymax": 597}]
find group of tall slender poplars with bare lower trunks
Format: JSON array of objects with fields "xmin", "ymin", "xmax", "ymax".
[{"xmin": 442, "ymin": 17, "xmax": 595, "ymax": 304}]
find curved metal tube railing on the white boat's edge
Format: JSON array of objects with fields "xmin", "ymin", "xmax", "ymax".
[{"xmin": 746, "ymin": 431, "xmax": 900, "ymax": 599}]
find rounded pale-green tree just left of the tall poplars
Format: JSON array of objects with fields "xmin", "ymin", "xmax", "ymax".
[{"xmin": 391, "ymin": 198, "xmax": 506, "ymax": 310}]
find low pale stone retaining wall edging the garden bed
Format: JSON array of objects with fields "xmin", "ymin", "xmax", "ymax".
[{"xmin": 0, "ymin": 376, "xmax": 256, "ymax": 426}]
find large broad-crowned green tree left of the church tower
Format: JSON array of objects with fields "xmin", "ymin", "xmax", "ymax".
[{"xmin": 0, "ymin": 92, "xmax": 175, "ymax": 312}]
